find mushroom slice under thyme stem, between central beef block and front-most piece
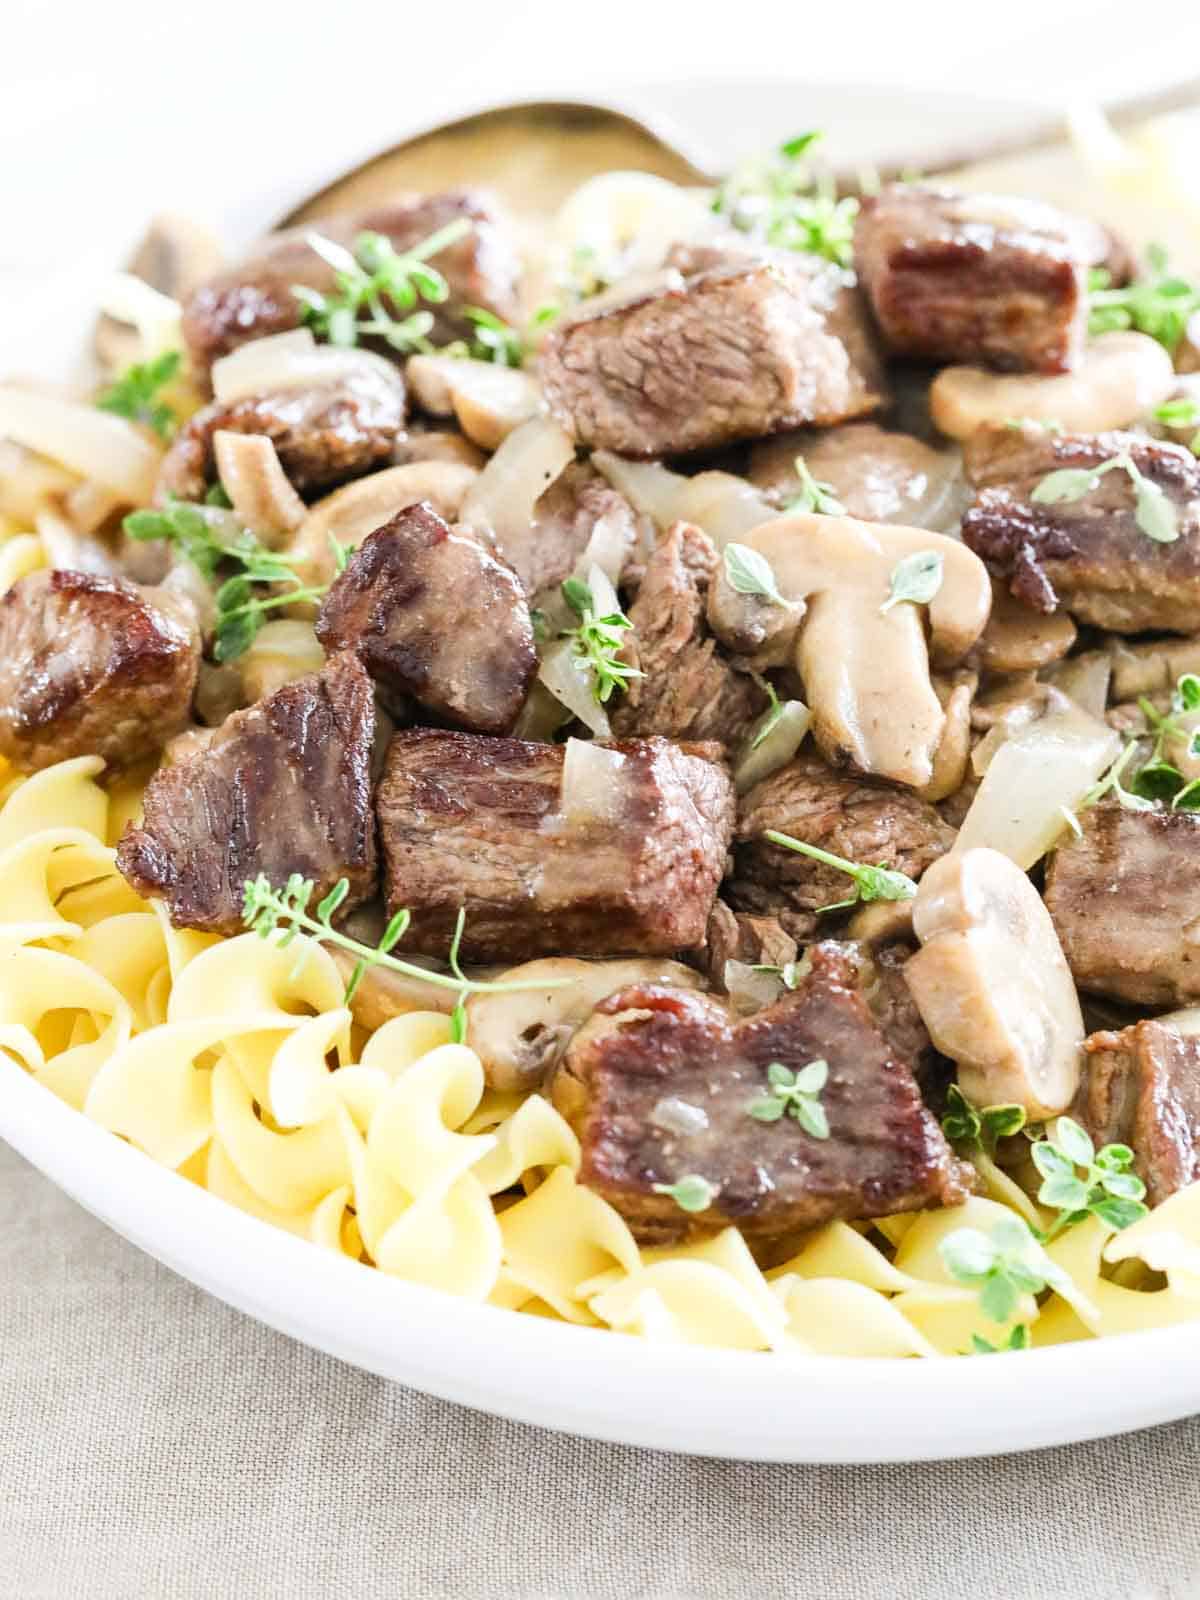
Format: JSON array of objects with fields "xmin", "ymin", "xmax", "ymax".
[{"xmin": 467, "ymin": 955, "xmax": 702, "ymax": 1090}]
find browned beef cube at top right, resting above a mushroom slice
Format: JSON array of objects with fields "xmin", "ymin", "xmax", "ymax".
[{"xmin": 854, "ymin": 184, "xmax": 1110, "ymax": 373}]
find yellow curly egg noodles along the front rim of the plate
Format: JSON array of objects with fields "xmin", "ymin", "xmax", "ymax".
[{"xmin": 0, "ymin": 758, "xmax": 1200, "ymax": 1357}]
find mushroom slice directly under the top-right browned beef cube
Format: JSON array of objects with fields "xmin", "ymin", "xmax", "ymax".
[{"xmin": 930, "ymin": 333, "xmax": 1174, "ymax": 438}]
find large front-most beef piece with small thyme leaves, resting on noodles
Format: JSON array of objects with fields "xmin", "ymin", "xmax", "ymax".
[{"xmin": 552, "ymin": 944, "xmax": 971, "ymax": 1242}]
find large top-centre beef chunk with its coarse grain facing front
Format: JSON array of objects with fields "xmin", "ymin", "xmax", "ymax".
[{"xmin": 541, "ymin": 258, "xmax": 880, "ymax": 456}]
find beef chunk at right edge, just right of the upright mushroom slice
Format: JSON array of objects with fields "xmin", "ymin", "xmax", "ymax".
[{"xmin": 1046, "ymin": 805, "xmax": 1200, "ymax": 1005}]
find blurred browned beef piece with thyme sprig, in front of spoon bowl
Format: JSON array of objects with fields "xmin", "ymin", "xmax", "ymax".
[{"xmin": 184, "ymin": 190, "xmax": 520, "ymax": 373}]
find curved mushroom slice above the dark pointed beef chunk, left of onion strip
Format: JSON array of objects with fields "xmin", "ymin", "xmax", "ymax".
[{"xmin": 288, "ymin": 461, "xmax": 478, "ymax": 584}]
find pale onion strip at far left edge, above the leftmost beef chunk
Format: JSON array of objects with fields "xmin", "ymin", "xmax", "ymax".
[{"xmin": 0, "ymin": 384, "xmax": 162, "ymax": 506}]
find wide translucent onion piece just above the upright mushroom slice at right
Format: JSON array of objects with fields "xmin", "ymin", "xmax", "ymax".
[{"xmin": 954, "ymin": 706, "xmax": 1122, "ymax": 872}]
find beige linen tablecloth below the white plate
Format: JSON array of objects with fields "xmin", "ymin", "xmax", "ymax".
[{"xmin": 0, "ymin": 1144, "xmax": 1200, "ymax": 1600}]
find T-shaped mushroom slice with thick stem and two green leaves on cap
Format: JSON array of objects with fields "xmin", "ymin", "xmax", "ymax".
[{"xmin": 709, "ymin": 514, "xmax": 992, "ymax": 789}]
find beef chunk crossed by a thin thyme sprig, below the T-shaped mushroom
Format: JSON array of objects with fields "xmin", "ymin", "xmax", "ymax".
[{"xmin": 728, "ymin": 754, "xmax": 954, "ymax": 942}]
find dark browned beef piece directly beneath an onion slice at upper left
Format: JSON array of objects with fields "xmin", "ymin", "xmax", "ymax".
[{"xmin": 158, "ymin": 370, "xmax": 405, "ymax": 501}]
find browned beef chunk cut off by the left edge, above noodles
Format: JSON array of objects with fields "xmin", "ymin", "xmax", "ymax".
[{"xmin": 0, "ymin": 568, "xmax": 200, "ymax": 771}]
